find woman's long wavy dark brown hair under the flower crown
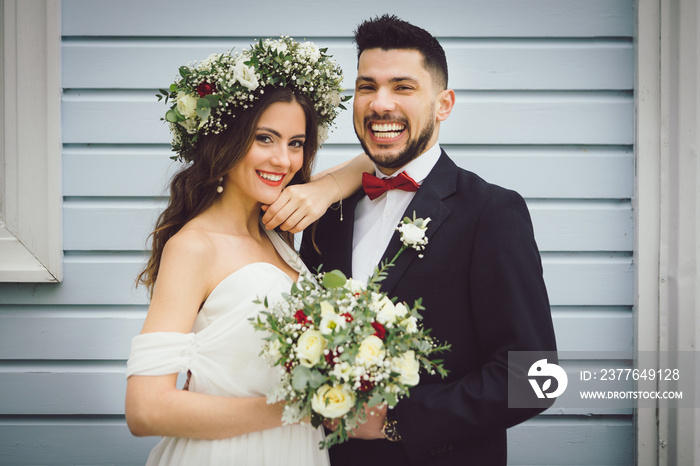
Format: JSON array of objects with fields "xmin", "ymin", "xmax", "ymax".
[{"xmin": 136, "ymin": 87, "xmax": 318, "ymax": 296}]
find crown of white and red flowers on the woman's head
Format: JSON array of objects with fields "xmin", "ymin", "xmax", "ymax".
[{"xmin": 156, "ymin": 36, "xmax": 350, "ymax": 162}]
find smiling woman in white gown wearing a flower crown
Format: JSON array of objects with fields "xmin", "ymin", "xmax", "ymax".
[{"xmin": 126, "ymin": 38, "xmax": 370, "ymax": 465}]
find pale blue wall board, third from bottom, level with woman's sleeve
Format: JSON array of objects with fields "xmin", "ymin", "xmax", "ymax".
[{"xmin": 0, "ymin": 304, "xmax": 633, "ymax": 362}]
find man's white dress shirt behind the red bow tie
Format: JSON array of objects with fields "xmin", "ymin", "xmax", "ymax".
[{"xmin": 352, "ymin": 144, "xmax": 442, "ymax": 283}]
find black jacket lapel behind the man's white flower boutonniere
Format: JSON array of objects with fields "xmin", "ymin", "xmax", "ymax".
[{"xmin": 374, "ymin": 151, "xmax": 457, "ymax": 295}]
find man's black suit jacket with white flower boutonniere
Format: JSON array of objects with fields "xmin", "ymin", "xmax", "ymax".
[{"xmin": 301, "ymin": 151, "xmax": 556, "ymax": 466}]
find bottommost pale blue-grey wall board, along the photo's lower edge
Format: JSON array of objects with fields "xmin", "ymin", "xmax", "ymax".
[{"xmin": 0, "ymin": 416, "xmax": 634, "ymax": 466}]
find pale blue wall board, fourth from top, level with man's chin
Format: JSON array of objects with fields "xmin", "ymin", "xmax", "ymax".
[{"xmin": 63, "ymin": 145, "xmax": 634, "ymax": 200}]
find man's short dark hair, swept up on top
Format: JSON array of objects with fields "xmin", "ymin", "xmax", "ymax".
[{"xmin": 355, "ymin": 15, "xmax": 447, "ymax": 89}]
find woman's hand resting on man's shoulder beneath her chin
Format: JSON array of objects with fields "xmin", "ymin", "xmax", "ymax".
[{"xmin": 262, "ymin": 175, "xmax": 339, "ymax": 233}]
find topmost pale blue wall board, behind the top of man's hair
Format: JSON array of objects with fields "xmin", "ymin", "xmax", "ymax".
[{"xmin": 63, "ymin": 0, "xmax": 634, "ymax": 38}]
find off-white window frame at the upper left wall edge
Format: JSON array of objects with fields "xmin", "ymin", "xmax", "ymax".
[{"xmin": 0, "ymin": 0, "xmax": 63, "ymax": 282}]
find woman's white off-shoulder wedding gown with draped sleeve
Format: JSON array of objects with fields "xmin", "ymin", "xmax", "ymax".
[{"xmin": 127, "ymin": 228, "xmax": 329, "ymax": 466}]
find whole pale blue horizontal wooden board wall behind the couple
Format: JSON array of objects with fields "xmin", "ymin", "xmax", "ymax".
[{"xmin": 0, "ymin": 0, "xmax": 634, "ymax": 465}]
